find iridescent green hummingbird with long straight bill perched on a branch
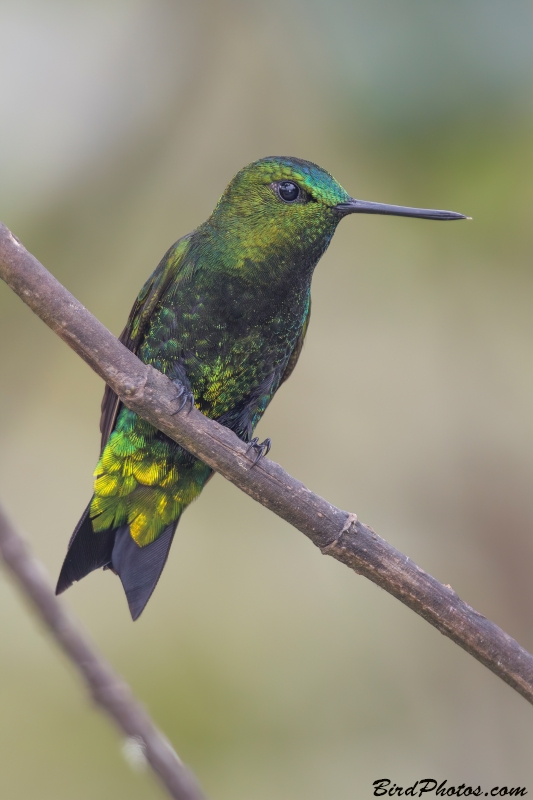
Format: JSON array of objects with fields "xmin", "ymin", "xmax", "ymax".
[{"xmin": 56, "ymin": 157, "xmax": 465, "ymax": 619}]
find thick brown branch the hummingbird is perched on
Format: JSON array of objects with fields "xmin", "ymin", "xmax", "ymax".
[{"xmin": 0, "ymin": 223, "xmax": 533, "ymax": 703}]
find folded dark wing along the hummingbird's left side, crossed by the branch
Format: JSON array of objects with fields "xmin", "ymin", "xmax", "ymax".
[{"xmin": 100, "ymin": 236, "xmax": 190, "ymax": 451}]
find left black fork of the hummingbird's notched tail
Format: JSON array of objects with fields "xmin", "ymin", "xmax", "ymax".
[{"xmin": 56, "ymin": 504, "xmax": 115, "ymax": 594}]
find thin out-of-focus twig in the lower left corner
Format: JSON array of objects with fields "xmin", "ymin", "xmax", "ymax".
[{"xmin": 0, "ymin": 507, "xmax": 204, "ymax": 800}]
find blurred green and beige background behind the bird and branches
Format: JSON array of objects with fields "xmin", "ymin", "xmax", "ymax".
[{"xmin": 0, "ymin": 0, "xmax": 533, "ymax": 800}]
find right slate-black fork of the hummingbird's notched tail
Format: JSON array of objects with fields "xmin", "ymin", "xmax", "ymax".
[{"xmin": 110, "ymin": 520, "xmax": 178, "ymax": 620}]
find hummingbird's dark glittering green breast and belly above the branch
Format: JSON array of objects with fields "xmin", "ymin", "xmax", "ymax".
[{"xmin": 139, "ymin": 268, "xmax": 309, "ymax": 418}]
